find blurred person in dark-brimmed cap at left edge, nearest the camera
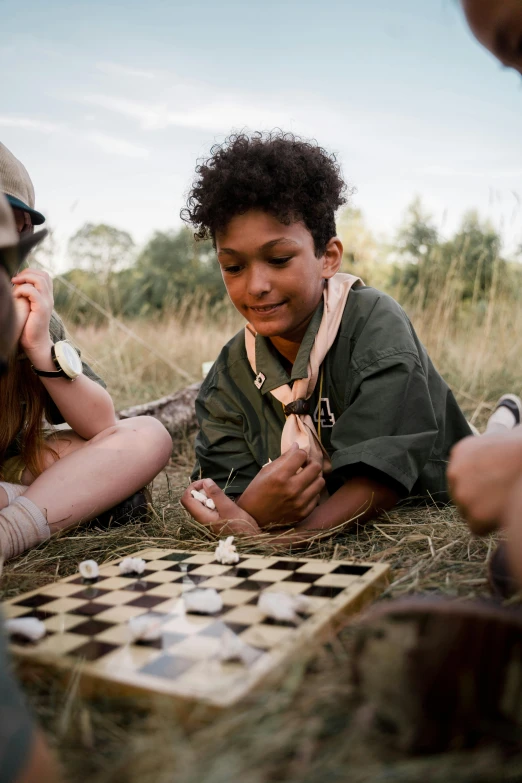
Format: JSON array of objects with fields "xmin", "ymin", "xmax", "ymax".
[{"xmin": 0, "ymin": 193, "xmax": 60, "ymax": 783}]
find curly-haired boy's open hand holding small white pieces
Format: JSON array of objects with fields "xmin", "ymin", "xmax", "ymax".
[{"xmin": 181, "ymin": 479, "xmax": 261, "ymax": 536}]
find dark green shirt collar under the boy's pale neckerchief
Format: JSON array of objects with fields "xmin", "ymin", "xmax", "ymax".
[{"xmin": 251, "ymin": 299, "xmax": 324, "ymax": 394}]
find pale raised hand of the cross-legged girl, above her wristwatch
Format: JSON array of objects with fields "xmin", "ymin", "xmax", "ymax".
[{"xmin": 12, "ymin": 269, "xmax": 54, "ymax": 366}]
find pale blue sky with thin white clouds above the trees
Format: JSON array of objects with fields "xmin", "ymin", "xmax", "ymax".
[{"xmin": 0, "ymin": 0, "xmax": 522, "ymax": 268}]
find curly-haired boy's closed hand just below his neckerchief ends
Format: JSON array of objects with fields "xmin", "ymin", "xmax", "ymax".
[{"xmin": 237, "ymin": 443, "xmax": 325, "ymax": 528}]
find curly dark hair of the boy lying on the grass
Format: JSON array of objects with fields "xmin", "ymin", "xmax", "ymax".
[{"xmin": 181, "ymin": 130, "xmax": 347, "ymax": 256}]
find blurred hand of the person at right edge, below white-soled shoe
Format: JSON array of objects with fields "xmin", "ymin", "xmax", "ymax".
[{"xmin": 448, "ymin": 427, "xmax": 522, "ymax": 535}]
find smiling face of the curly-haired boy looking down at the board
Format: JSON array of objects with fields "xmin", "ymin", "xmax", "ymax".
[{"xmin": 216, "ymin": 210, "xmax": 342, "ymax": 343}]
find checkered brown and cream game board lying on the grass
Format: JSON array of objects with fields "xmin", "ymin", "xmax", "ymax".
[{"xmin": 4, "ymin": 549, "xmax": 389, "ymax": 707}]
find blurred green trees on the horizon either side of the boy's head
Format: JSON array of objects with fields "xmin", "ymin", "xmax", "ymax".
[{"xmin": 49, "ymin": 198, "xmax": 522, "ymax": 324}]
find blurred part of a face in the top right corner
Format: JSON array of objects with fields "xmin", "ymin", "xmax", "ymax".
[{"xmin": 462, "ymin": 0, "xmax": 522, "ymax": 73}]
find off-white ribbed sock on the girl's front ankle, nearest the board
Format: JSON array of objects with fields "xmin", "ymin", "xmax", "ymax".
[{"xmin": 0, "ymin": 495, "xmax": 51, "ymax": 561}]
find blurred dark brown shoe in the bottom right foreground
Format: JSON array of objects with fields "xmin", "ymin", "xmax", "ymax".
[{"xmin": 349, "ymin": 597, "xmax": 522, "ymax": 753}]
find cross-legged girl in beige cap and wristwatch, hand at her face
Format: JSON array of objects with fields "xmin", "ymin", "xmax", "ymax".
[{"xmin": 0, "ymin": 145, "xmax": 172, "ymax": 560}]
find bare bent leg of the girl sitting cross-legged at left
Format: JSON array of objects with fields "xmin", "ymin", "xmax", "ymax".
[{"xmin": 22, "ymin": 416, "xmax": 172, "ymax": 533}]
